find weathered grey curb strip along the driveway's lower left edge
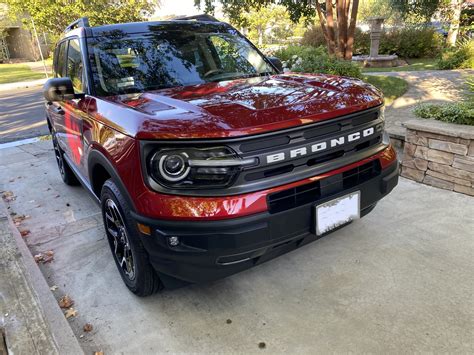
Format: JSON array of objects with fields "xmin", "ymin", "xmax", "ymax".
[{"xmin": 0, "ymin": 201, "xmax": 84, "ymax": 354}]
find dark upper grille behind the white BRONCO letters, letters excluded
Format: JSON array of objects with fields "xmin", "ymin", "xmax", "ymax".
[{"xmin": 232, "ymin": 108, "xmax": 383, "ymax": 186}]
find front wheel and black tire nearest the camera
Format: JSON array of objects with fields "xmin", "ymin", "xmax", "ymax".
[{"xmin": 101, "ymin": 179, "xmax": 163, "ymax": 297}]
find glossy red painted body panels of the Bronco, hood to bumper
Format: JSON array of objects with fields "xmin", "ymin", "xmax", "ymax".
[{"xmin": 54, "ymin": 74, "xmax": 388, "ymax": 220}]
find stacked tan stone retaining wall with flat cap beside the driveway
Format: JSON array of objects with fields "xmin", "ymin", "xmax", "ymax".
[{"xmin": 401, "ymin": 120, "xmax": 474, "ymax": 196}]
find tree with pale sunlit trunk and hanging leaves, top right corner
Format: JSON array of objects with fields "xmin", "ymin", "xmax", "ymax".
[{"xmin": 391, "ymin": 0, "xmax": 466, "ymax": 46}]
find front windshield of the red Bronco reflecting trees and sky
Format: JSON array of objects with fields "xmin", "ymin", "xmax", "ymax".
[{"xmin": 89, "ymin": 29, "xmax": 275, "ymax": 96}]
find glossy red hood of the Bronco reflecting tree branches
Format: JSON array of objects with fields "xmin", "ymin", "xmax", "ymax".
[{"xmin": 106, "ymin": 74, "xmax": 383, "ymax": 139}]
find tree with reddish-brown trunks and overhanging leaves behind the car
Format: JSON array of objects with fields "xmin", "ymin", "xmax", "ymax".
[{"xmin": 195, "ymin": 0, "xmax": 359, "ymax": 60}]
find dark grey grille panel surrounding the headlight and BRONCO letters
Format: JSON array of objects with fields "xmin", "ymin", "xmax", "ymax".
[{"xmin": 140, "ymin": 106, "xmax": 389, "ymax": 197}]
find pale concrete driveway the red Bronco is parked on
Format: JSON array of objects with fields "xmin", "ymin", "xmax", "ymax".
[{"xmin": 0, "ymin": 142, "xmax": 474, "ymax": 354}]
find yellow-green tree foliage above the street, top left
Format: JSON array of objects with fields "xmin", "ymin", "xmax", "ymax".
[{"xmin": 1, "ymin": 0, "xmax": 157, "ymax": 36}]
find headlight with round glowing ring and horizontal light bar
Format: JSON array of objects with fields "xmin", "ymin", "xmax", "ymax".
[{"xmin": 148, "ymin": 147, "xmax": 257, "ymax": 189}]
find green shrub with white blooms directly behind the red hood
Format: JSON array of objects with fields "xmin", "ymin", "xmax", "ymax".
[{"xmin": 275, "ymin": 46, "xmax": 362, "ymax": 78}]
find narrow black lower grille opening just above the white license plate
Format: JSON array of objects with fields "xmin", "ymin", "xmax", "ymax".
[{"xmin": 267, "ymin": 159, "xmax": 381, "ymax": 214}]
